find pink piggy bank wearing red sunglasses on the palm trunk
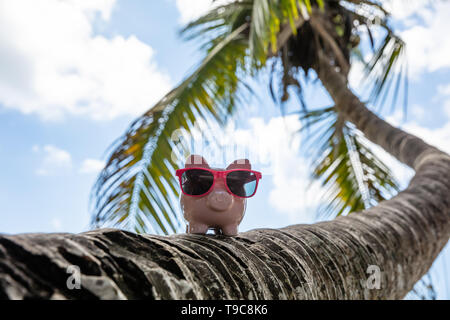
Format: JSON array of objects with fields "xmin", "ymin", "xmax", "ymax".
[{"xmin": 176, "ymin": 155, "xmax": 261, "ymax": 236}]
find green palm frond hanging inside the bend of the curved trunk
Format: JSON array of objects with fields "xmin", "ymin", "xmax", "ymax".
[{"xmin": 301, "ymin": 107, "xmax": 398, "ymax": 216}]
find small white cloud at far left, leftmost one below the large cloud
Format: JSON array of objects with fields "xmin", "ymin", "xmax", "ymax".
[{"xmin": 32, "ymin": 144, "xmax": 72, "ymax": 176}]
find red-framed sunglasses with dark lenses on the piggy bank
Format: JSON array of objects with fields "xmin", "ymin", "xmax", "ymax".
[{"xmin": 176, "ymin": 168, "xmax": 262, "ymax": 198}]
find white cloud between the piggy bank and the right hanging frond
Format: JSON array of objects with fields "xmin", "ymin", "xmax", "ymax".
[{"xmin": 237, "ymin": 115, "xmax": 323, "ymax": 223}]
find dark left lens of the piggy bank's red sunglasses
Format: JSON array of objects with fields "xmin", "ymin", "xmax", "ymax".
[{"xmin": 181, "ymin": 169, "xmax": 214, "ymax": 196}]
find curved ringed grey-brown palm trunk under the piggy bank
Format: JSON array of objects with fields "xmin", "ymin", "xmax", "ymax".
[{"xmin": 0, "ymin": 58, "xmax": 450, "ymax": 299}]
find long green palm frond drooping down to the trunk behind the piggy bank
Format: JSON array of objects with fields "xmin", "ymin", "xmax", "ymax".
[{"xmin": 92, "ymin": 23, "xmax": 248, "ymax": 234}]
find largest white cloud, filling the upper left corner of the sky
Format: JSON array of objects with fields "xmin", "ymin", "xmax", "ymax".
[{"xmin": 0, "ymin": 0, "xmax": 170, "ymax": 119}]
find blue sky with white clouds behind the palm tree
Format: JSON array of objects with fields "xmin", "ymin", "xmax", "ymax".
[{"xmin": 0, "ymin": 0, "xmax": 450, "ymax": 298}]
